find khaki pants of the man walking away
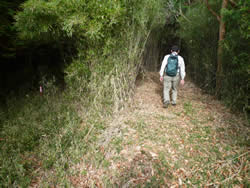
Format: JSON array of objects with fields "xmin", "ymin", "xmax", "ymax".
[{"xmin": 163, "ymin": 74, "xmax": 180, "ymax": 104}]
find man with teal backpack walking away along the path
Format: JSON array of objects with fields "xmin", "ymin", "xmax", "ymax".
[{"xmin": 160, "ymin": 46, "xmax": 186, "ymax": 108}]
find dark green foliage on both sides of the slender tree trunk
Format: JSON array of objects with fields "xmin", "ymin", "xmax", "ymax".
[{"xmin": 179, "ymin": 1, "xmax": 250, "ymax": 117}]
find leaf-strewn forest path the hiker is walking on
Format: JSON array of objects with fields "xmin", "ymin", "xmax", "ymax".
[{"xmin": 72, "ymin": 72, "xmax": 250, "ymax": 188}]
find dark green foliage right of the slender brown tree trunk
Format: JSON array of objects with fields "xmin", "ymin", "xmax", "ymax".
[{"xmin": 222, "ymin": 0, "xmax": 250, "ymax": 113}]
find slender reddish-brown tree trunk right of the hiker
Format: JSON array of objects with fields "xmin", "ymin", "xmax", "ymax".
[{"xmin": 215, "ymin": 0, "xmax": 228, "ymax": 97}]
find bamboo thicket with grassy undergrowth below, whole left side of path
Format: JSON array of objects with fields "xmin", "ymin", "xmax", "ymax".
[{"xmin": 0, "ymin": 0, "xmax": 168, "ymax": 187}]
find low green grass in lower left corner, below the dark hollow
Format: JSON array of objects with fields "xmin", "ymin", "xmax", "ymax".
[{"xmin": 0, "ymin": 83, "xmax": 108, "ymax": 187}]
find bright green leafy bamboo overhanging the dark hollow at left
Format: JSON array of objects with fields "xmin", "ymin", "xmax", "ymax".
[{"xmin": 16, "ymin": 0, "xmax": 164, "ymax": 108}]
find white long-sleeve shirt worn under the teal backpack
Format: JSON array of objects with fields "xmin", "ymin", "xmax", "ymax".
[{"xmin": 159, "ymin": 53, "xmax": 186, "ymax": 80}]
